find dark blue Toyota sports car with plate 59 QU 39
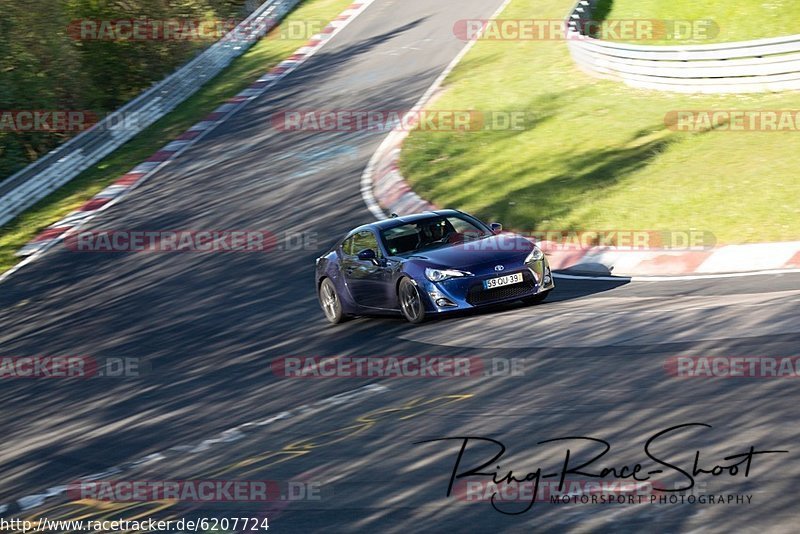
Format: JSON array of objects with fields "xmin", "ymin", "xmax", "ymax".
[{"xmin": 316, "ymin": 210, "xmax": 555, "ymax": 323}]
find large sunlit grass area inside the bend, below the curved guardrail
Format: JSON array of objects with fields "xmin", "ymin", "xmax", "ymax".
[{"xmin": 401, "ymin": 0, "xmax": 800, "ymax": 243}]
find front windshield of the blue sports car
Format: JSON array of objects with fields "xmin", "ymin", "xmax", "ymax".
[{"xmin": 381, "ymin": 216, "xmax": 492, "ymax": 256}]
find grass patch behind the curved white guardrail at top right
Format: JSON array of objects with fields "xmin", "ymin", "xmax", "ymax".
[{"xmin": 598, "ymin": 0, "xmax": 800, "ymax": 44}]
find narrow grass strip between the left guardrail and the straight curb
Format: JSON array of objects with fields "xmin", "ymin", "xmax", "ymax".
[{"xmin": 0, "ymin": 0, "xmax": 352, "ymax": 272}]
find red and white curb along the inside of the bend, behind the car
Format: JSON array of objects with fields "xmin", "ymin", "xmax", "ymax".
[{"xmin": 361, "ymin": 2, "xmax": 800, "ymax": 281}]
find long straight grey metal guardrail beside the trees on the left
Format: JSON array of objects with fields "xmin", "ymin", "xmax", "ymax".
[{"xmin": 0, "ymin": 0, "xmax": 302, "ymax": 225}]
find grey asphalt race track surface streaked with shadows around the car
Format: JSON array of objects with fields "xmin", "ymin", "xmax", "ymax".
[{"xmin": 0, "ymin": 0, "xmax": 800, "ymax": 532}]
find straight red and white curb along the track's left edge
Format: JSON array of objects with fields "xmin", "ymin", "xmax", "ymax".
[{"xmin": 0, "ymin": 0, "xmax": 375, "ymax": 281}]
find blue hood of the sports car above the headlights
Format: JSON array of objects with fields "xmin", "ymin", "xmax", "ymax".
[{"xmin": 409, "ymin": 234, "xmax": 533, "ymax": 271}]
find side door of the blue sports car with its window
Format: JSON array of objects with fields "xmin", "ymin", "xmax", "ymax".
[{"xmin": 342, "ymin": 230, "xmax": 392, "ymax": 309}]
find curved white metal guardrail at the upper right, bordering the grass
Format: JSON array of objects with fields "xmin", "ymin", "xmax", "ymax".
[{"xmin": 567, "ymin": 0, "xmax": 800, "ymax": 93}]
